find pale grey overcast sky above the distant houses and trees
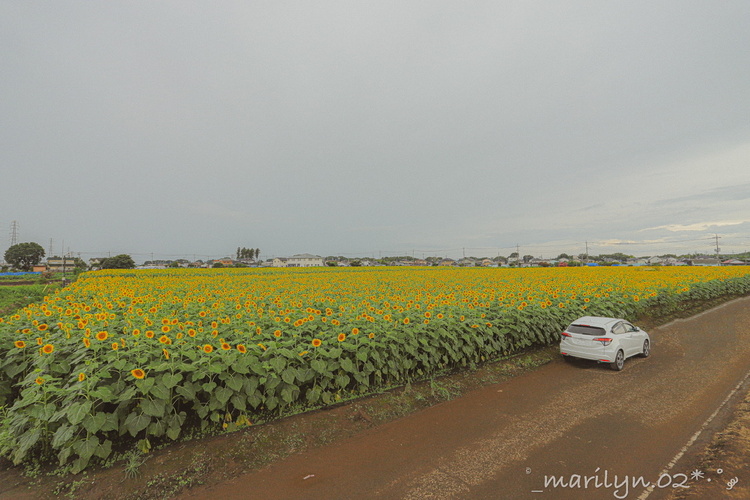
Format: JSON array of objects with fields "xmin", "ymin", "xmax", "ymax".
[{"xmin": 0, "ymin": 0, "xmax": 750, "ymax": 262}]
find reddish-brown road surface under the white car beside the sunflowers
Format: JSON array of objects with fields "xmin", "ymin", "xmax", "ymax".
[{"xmin": 185, "ymin": 298, "xmax": 750, "ymax": 500}]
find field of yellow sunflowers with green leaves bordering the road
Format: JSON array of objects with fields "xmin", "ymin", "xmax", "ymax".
[{"xmin": 0, "ymin": 267, "xmax": 750, "ymax": 472}]
